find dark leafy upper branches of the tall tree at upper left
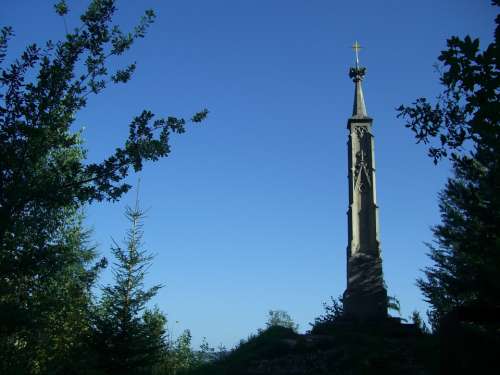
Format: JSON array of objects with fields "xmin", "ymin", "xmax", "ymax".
[{"xmin": 0, "ymin": 0, "xmax": 208, "ymax": 209}]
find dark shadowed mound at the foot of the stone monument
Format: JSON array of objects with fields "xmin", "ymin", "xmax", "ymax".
[{"xmin": 184, "ymin": 321, "xmax": 437, "ymax": 375}]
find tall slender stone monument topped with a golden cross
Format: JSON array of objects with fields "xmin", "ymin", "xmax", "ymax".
[{"xmin": 343, "ymin": 42, "xmax": 387, "ymax": 320}]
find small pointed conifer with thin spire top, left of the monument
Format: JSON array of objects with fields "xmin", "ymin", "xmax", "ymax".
[{"xmin": 94, "ymin": 203, "xmax": 170, "ymax": 375}]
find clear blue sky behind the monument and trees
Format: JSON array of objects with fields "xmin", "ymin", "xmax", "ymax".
[{"xmin": 0, "ymin": 0, "xmax": 495, "ymax": 347}]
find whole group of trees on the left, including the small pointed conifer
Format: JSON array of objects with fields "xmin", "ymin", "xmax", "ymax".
[{"xmin": 0, "ymin": 0, "xmax": 207, "ymax": 375}]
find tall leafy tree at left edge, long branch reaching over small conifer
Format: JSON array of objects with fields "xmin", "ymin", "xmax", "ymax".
[{"xmin": 0, "ymin": 0, "xmax": 207, "ymax": 373}]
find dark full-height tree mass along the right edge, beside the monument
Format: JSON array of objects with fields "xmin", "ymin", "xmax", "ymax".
[{"xmin": 399, "ymin": 0, "xmax": 500, "ymax": 330}]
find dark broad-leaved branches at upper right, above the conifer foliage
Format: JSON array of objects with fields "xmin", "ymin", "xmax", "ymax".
[{"xmin": 397, "ymin": 22, "xmax": 500, "ymax": 163}]
